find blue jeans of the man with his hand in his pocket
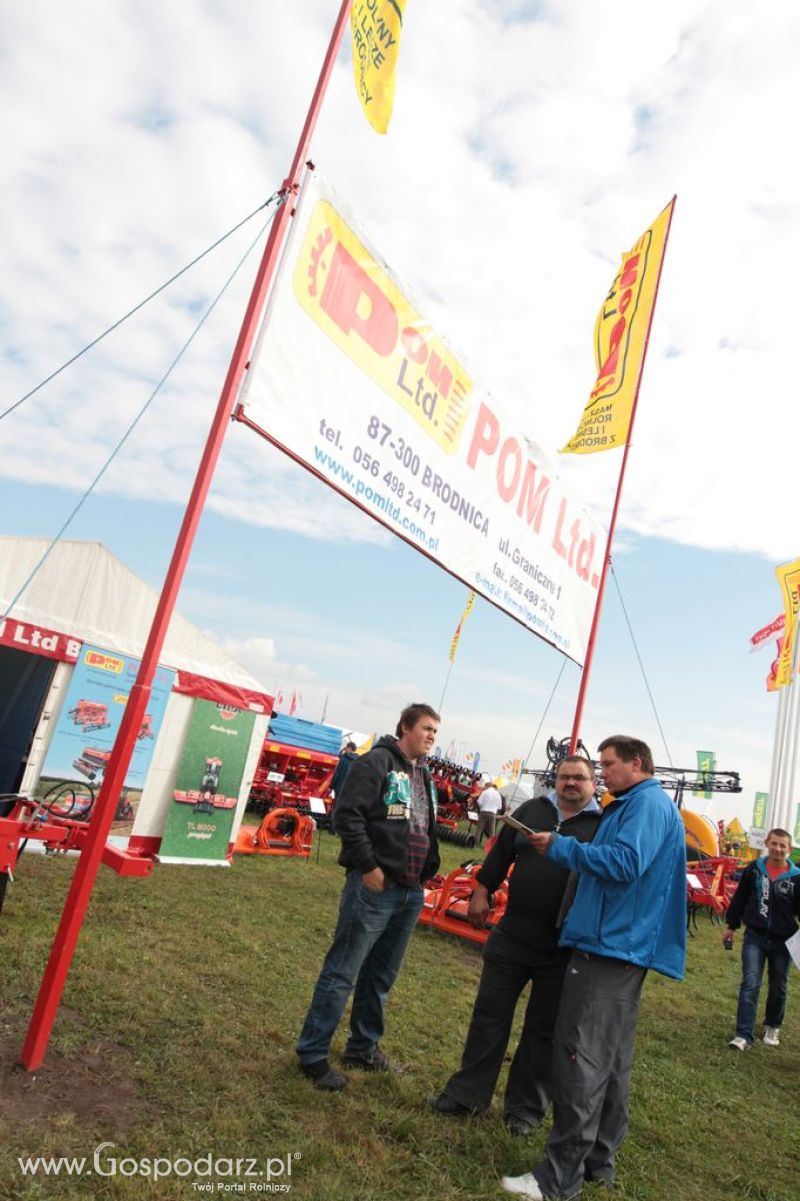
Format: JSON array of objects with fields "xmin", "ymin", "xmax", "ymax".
[{"xmin": 295, "ymin": 871, "xmax": 423, "ymax": 1064}]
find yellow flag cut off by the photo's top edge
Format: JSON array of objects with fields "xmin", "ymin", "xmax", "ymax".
[{"xmin": 350, "ymin": 0, "xmax": 406, "ymax": 133}]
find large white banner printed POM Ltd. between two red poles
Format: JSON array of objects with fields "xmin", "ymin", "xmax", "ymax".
[{"xmin": 241, "ymin": 175, "xmax": 605, "ymax": 663}]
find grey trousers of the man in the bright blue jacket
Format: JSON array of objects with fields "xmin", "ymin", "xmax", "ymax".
[{"xmin": 533, "ymin": 951, "xmax": 646, "ymax": 1197}]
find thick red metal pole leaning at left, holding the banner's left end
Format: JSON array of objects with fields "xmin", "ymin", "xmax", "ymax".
[{"xmin": 20, "ymin": 0, "xmax": 351, "ymax": 1071}]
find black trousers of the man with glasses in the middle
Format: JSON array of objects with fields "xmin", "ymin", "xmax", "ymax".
[{"xmin": 444, "ymin": 930, "xmax": 569, "ymax": 1122}]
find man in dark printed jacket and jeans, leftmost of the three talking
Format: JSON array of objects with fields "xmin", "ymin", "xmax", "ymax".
[{"xmin": 297, "ymin": 705, "xmax": 440, "ymax": 1092}]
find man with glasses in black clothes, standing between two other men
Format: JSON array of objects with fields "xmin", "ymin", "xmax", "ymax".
[{"xmin": 429, "ymin": 755, "xmax": 601, "ymax": 1135}]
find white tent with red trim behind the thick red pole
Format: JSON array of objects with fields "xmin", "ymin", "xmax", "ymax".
[{"xmin": 0, "ymin": 537, "xmax": 271, "ymax": 853}]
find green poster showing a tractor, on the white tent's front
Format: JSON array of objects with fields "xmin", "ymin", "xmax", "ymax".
[{"xmin": 159, "ymin": 700, "xmax": 256, "ymax": 865}]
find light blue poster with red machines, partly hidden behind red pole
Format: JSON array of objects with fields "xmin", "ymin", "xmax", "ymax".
[{"xmin": 36, "ymin": 644, "xmax": 175, "ymax": 833}]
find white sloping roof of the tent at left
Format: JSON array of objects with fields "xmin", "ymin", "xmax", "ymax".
[{"xmin": 0, "ymin": 536, "xmax": 265, "ymax": 693}]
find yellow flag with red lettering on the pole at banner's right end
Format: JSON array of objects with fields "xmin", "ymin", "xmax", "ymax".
[{"xmin": 561, "ymin": 197, "xmax": 675, "ymax": 454}]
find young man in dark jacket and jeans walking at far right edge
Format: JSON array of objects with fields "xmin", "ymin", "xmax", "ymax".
[{"xmin": 722, "ymin": 829, "xmax": 800, "ymax": 1051}]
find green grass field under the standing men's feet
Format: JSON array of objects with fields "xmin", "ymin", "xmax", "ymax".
[{"xmin": 0, "ymin": 835, "xmax": 800, "ymax": 1201}]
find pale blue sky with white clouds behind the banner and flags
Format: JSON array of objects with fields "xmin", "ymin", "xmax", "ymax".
[{"xmin": 0, "ymin": 0, "xmax": 800, "ymax": 820}]
